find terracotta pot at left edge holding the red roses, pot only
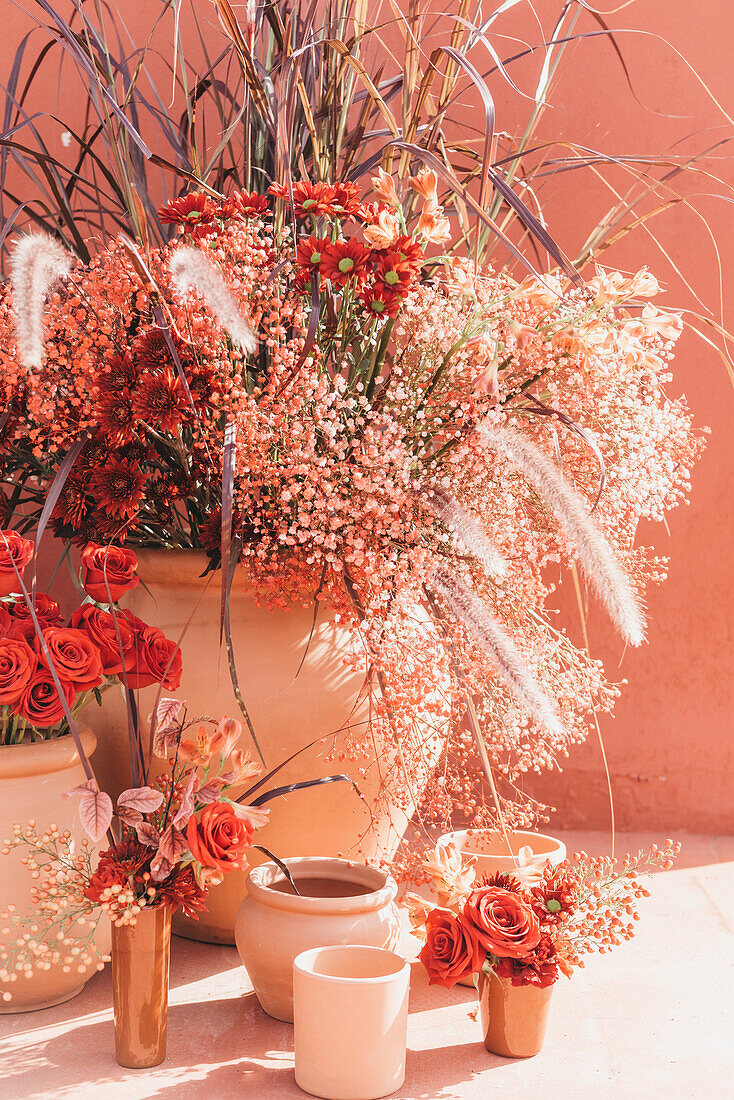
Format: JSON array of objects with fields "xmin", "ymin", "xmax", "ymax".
[{"xmin": 0, "ymin": 727, "xmax": 110, "ymax": 1013}]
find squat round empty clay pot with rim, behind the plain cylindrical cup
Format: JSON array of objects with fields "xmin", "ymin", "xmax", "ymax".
[{"xmin": 235, "ymin": 858, "xmax": 401, "ymax": 1021}]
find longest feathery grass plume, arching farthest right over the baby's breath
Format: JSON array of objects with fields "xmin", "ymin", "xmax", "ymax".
[{"xmin": 479, "ymin": 422, "xmax": 645, "ymax": 646}]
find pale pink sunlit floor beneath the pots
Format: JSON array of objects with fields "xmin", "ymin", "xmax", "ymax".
[{"xmin": 0, "ymin": 833, "xmax": 734, "ymax": 1100}]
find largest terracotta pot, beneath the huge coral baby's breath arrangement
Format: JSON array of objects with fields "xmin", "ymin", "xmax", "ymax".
[{"xmin": 98, "ymin": 550, "xmax": 440, "ymax": 944}]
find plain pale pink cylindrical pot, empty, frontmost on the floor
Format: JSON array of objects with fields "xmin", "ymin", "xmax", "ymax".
[{"xmin": 293, "ymin": 946, "xmax": 410, "ymax": 1100}]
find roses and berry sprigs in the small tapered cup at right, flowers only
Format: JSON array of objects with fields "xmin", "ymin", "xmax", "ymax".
[{"xmin": 406, "ymin": 840, "xmax": 680, "ymax": 988}]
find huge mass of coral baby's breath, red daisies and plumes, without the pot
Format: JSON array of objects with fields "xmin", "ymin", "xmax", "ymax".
[{"xmin": 0, "ymin": 160, "xmax": 701, "ymax": 893}]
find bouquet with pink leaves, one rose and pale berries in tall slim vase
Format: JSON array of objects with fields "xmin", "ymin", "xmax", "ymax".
[{"xmin": 0, "ymin": 699, "xmax": 273, "ymax": 1000}]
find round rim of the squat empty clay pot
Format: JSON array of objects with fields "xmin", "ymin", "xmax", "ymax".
[{"xmin": 248, "ymin": 856, "xmax": 397, "ymax": 914}]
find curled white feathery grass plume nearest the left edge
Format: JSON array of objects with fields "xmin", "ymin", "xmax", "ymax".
[{"xmin": 10, "ymin": 233, "xmax": 72, "ymax": 370}]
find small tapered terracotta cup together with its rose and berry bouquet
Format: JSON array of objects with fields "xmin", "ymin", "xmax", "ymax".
[{"xmin": 406, "ymin": 840, "xmax": 680, "ymax": 1057}]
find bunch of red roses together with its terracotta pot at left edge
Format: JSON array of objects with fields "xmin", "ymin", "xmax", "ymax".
[{"xmin": 0, "ymin": 530, "xmax": 180, "ymax": 1011}]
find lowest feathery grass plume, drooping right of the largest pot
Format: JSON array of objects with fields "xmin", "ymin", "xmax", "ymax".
[{"xmin": 430, "ymin": 570, "xmax": 563, "ymax": 736}]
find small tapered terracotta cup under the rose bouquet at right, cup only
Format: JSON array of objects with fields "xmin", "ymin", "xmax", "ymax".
[{"xmin": 476, "ymin": 972, "xmax": 554, "ymax": 1058}]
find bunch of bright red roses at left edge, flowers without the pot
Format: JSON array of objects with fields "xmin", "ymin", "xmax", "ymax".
[{"xmin": 0, "ymin": 530, "xmax": 182, "ymax": 745}]
